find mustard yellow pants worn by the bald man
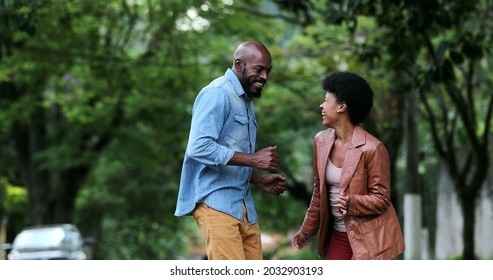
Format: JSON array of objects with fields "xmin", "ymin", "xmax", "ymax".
[{"xmin": 192, "ymin": 203, "xmax": 263, "ymax": 260}]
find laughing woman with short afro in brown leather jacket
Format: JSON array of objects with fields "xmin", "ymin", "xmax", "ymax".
[{"xmin": 293, "ymin": 72, "xmax": 404, "ymax": 260}]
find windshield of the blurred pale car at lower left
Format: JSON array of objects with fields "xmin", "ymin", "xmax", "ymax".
[{"xmin": 13, "ymin": 228, "xmax": 65, "ymax": 249}]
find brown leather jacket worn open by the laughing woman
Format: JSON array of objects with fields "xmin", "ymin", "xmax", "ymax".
[{"xmin": 301, "ymin": 126, "xmax": 404, "ymax": 260}]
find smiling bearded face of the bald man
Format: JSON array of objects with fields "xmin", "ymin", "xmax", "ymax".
[{"xmin": 240, "ymin": 56, "xmax": 272, "ymax": 98}]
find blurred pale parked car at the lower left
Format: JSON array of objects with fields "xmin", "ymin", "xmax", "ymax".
[{"xmin": 6, "ymin": 224, "xmax": 92, "ymax": 260}]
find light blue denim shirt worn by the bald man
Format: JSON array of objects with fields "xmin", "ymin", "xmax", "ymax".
[{"xmin": 175, "ymin": 69, "xmax": 258, "ymax": 224}]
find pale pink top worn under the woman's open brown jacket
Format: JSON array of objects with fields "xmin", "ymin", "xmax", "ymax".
[{"xmin": 325, "ymin": 159, "xmax": 346, "ymax": 232}]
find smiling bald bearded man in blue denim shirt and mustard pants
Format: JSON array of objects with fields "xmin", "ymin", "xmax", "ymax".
[{"xmin": 175, "ymin": 41, "xmax": 286, "ymax": 260}]
